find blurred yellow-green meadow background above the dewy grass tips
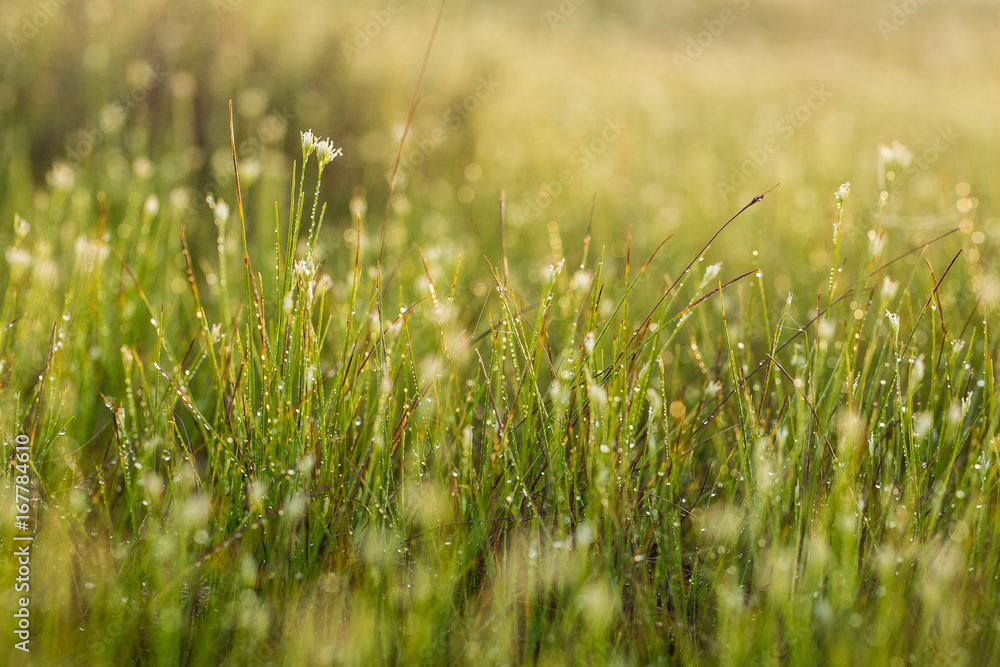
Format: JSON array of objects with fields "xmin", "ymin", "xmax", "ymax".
[{"xmin": 0, "ymin": 0, "xmax": 1000, "ymax": 312}]
